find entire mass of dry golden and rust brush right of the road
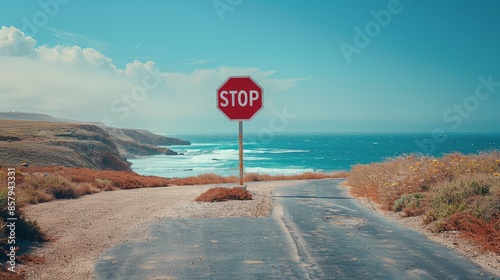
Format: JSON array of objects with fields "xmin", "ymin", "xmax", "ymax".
[{"xmin": 346, "ymin": 151, "xmax": 500, "ymax": 253}]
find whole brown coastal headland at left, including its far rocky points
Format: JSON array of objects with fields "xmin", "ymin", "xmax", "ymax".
[{"xmin": 0, "ymin": 113, "xmax": 190, "ymax": 171}]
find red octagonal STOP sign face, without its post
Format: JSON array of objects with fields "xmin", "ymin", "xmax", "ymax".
[{"xmin": 217, "ymin": 77, "xmax": 263, "ymax": 121}]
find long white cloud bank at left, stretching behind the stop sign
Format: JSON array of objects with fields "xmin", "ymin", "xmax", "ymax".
[{"xmin": 0, "ymin": 27, "xmax": 303, "ymax": 130}]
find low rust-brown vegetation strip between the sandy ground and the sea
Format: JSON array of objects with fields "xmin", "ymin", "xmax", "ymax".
[{"xmin": 0, "ymin": 166, "xmax": 346, "ymax": 205}]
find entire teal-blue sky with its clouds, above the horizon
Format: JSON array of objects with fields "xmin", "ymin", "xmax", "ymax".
[{"xmin": 0, "ymin": 0, "xmax": 500, "ymax": 133}]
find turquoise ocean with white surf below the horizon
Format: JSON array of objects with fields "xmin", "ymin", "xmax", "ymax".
[{"xmin": 129, "ymin": 133, "xmax": 500, "ymax": 177}]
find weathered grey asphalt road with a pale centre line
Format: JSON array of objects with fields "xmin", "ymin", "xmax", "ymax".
[{"xmin": 94, "ymin": 180, "xmax": 495, "ymax": 279}]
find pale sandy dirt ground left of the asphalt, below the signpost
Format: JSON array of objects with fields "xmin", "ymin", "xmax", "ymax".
[{"xmin": 23, "ymin": 181, "xmax": 298, "ymax": 280}]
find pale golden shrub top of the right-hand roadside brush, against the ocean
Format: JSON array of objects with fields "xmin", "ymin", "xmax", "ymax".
[{"xmin": 346, "ymin": 151, "xmax": 500, "ymax": 210}]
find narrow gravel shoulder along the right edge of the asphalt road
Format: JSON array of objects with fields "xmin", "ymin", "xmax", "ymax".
[{"xmin": 346, "ymin": 186, "xmax": 500, "ymax": 276}]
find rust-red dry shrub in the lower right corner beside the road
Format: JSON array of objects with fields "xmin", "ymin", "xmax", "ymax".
[{"xmin": 444, "ymin": 213, "xmax": 500, "ymax": 254}]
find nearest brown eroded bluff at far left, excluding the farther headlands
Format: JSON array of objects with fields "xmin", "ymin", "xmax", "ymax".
[{"xmin": 0, "ymin": 120, "xmax": 132, "ymax": 171}]
